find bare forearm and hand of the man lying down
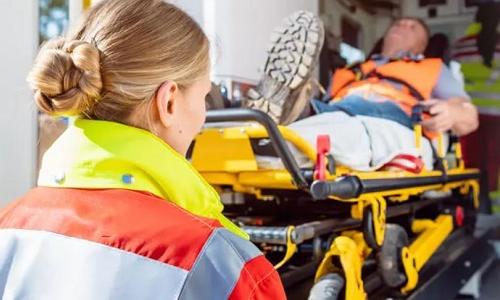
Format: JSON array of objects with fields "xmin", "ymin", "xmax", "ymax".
[{"xmin": 422, "ymin": 97, "xmax": 479, "ymax": 136}]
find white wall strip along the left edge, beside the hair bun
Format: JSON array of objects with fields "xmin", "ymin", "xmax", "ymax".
[{"xmin": 0, "ymin": 0, "xmax": 38, "ymax": 206}]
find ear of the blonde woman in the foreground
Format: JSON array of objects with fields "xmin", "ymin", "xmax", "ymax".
[{"xmin": 155, "ymin": 81, "xmax": 179, "ymax": 128}]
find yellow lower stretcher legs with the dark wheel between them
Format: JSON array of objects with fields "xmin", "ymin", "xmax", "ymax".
[{"xmin": 313, "ymin": 215, "xmax": 454, "ymax": 300}]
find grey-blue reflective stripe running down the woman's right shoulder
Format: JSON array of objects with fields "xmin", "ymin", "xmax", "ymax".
[{"xmin": 180, "ymin": 228, "xmax": 262, "ymax": 300}]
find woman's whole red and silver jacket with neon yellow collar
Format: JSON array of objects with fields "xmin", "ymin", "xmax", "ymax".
[{"xmin": 0, "ymin": 120, "xmax": 285, "ymax": 299}]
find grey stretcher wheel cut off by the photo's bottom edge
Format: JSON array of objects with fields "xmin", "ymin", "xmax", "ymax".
[{"xmin": 308, "ymin": 273, "xmax": 345, "ymax": 300}]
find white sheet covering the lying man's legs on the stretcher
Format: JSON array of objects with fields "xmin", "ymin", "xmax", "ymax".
[{"xmin": 282, "ymin": 112, "xmax": 433, "ymax": 171}]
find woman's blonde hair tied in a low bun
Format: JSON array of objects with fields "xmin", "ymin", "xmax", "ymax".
[{"xmin": 28, "ymin": 0, "xmax": 210, "ymax": 123}]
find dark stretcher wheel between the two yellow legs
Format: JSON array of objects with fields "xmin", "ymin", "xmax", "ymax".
[{"xmin": 377, "ymin": 224, "xmax": 409, "ymax": 288}]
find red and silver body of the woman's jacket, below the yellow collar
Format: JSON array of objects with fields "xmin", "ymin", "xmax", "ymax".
[{"xmin": 0, "ymin": 188, "xmax": 285, "ymax": 300}]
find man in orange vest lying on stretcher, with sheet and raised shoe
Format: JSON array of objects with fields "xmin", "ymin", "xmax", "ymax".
[{"xmin": 244, "ymin": 16, "xmax": 478, "ymax": 171}]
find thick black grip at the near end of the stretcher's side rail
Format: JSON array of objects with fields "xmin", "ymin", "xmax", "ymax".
[{"xmin": 311, "ymin": 176, "xmax": 363, "ymax": 200}]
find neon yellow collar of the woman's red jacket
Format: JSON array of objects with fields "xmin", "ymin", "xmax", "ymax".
[{"xmin": 38, "ymin": 119, "xmax": 248, "ymax": 239}]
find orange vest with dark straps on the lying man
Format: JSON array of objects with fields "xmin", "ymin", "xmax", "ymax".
[{"xmin": 330, "ymin": 58, "xmax": 443, "ymax": 137}]
